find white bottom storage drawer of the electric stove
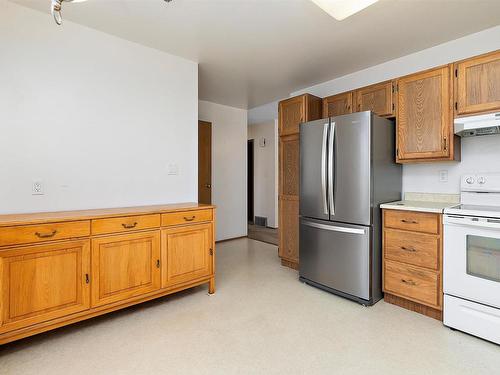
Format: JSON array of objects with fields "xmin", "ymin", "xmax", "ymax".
[{"xmin": 443, "ymin": 294, "xmax": 500, "ymax": 344}]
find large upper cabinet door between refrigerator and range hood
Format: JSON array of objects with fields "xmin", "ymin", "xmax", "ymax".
[{"xmin": 397, "ymin": 67, "xmax": 453, "ymax": 162}]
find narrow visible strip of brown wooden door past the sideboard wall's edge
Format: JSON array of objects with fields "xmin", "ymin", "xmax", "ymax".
[{"xmin": 198, "ymin": 121, "xmax": 212, "ymax": 204}]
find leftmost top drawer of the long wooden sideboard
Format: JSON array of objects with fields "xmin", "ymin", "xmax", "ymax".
[{"xmin": 0, "ymin": 220, "xmax": 90, "ymax": 246}]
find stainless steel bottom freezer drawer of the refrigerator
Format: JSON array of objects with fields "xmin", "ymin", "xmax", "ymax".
[{"xmin": 299, "ymin": 218, "xmax": 372, "ymax": 300}]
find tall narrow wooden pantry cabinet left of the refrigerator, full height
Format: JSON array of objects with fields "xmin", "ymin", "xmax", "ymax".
[{"xmin": 278, "ymin": 94, "xmax": 322, "ymax": 268}]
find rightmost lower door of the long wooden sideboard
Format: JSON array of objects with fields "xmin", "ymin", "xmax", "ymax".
[{"xmin": 161, "ymin": 224, "xmax": 214, "ymax": 288}]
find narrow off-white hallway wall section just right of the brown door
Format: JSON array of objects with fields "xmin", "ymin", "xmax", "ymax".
[{"xmin": 198, "ymin": 100, "xmax": 247, "ymax": 241}]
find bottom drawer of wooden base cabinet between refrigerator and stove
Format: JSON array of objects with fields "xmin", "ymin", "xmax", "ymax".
[{"xmin": 384, "ymin": 260, "xmax": 440, "ymax": 309}]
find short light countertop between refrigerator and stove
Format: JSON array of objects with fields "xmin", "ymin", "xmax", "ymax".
[{"xmin": 380, "ymin": 193, "xmax": 460, "ymax": 213}]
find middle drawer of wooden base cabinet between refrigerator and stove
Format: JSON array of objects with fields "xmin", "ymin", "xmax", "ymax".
[{"xmin": 384, "ymin": 230, "xmax": 441, "ymax": 271}]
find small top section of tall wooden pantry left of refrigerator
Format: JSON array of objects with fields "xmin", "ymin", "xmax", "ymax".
[{"xmin": 278, "ymin": 94, "xmax": 321, "ymax": 136}]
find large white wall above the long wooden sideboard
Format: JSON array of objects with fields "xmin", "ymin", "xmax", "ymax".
[{"xmin": 0, "ymin": 0, "xmax": 198, "ymax": 213}]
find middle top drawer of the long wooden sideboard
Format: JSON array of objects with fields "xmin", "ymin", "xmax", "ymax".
[{"xmin": 92, "ymin": 214, "xmax": 160, "ymax": 235}]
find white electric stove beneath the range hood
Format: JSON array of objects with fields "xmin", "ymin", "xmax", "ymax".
[{"xmin": 443, "ymin": 174, "xmax": 500, "ymax": 344}]
